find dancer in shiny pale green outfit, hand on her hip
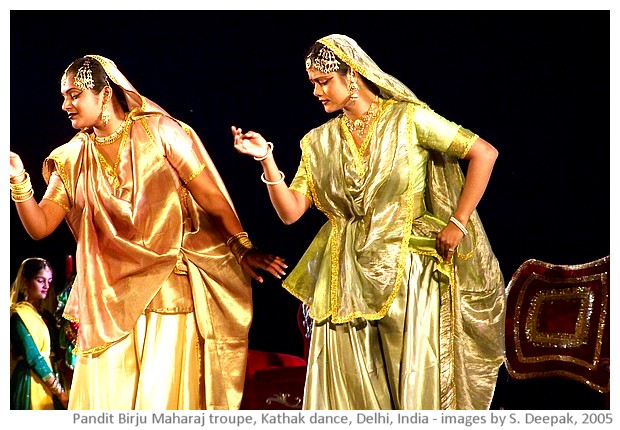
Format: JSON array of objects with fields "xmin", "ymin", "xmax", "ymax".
[{"xmin": 232, "ymin": 34, "xmax": 505, "ymax": 409}]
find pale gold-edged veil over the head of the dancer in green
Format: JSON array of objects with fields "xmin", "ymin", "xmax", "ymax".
[{"xmin": 317, "ymin": 34, "xmax": 420, "ymax": 103}]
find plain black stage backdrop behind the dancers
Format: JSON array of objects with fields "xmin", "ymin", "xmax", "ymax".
[{"xmin": 10, "ymin": 10, "xmax": 610, "ymax": 360}]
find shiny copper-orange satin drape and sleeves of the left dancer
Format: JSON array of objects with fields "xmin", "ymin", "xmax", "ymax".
[{"xmin": 43, "ymin": 56, "xmax": 252, "ymax": 409}]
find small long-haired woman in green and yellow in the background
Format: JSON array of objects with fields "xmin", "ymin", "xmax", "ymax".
[{"xmin": 11, "ymin": 258, "xmax": 68, "ymax": 410}]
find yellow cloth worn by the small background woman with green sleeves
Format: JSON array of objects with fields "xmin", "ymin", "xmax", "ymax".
[{"xmin": 11, "ymin": 302, "xmax": 55, "ymax": 410}]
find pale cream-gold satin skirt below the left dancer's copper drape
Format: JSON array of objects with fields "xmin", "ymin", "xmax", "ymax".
[{"xmin": 69, "ymin": 312, "xmax": 205, "ymax": 410}]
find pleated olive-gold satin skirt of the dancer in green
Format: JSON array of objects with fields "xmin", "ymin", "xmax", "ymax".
[{"xmin": 303, "ymin": 253, "xmax": 440, "ymax": 410}]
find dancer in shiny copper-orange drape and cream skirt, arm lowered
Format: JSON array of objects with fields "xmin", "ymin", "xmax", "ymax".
[{"xmin": 10, "ymin": 55, "xmax": 286, "ymax": 410}]
